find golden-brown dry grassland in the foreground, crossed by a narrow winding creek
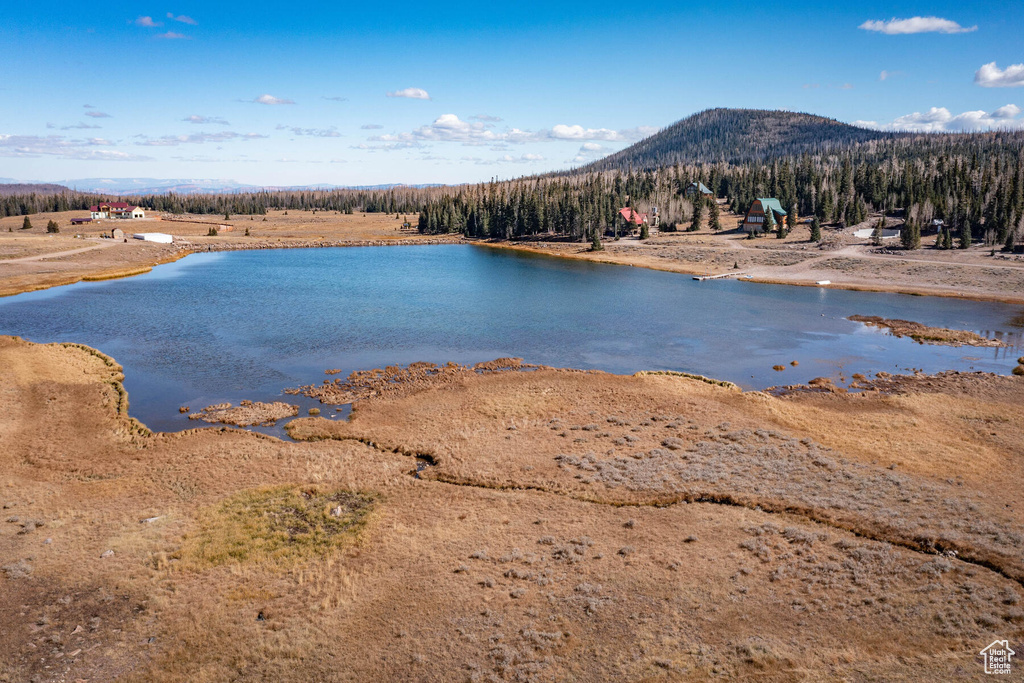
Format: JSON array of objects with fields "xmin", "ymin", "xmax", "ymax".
[{"xmin": 0, "ymin": 338, "xmax": 1024, "ymax": 682}]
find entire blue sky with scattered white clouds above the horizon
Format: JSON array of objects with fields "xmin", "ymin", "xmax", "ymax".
[{"xmin": 0, "ymin": 0, "xmax": 1024, "ymax": 185}]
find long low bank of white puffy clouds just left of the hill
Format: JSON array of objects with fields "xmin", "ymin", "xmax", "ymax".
[{"xmin": 371, "ymin": 114, "xmax": 657, "ymax": 145}]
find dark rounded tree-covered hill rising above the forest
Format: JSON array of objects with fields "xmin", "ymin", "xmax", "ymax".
[{"xmin": 580, "ymin": 109, "xmax": 901, "ymax": 172}]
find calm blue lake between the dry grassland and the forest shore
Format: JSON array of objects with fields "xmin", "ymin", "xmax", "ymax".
[{"xmin": 0, "ymin": 245, "xmax": 1024, "ymax": 430}]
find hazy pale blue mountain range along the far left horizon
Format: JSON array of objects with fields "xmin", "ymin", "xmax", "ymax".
[{"xmin": 0, "ymin": 178, "xmax": 435, "ymax": 196}]
